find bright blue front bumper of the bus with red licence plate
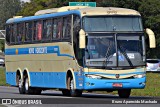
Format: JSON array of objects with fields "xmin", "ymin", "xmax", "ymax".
[{"xmin": 84, "ymin": 77, "xmax": 146, "ymax": 90}]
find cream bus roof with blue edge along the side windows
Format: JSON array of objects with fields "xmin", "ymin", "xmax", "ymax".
[{"xmin": 6, "ymin": 6, "xmax": 140, "ymax": 24}]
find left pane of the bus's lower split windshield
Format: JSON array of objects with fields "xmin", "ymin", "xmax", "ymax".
[{"xmin": 85, "ymin": 34, "xmax": 116, "ymax": 67}]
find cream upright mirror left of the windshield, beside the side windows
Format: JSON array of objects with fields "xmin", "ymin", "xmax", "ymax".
[{"xmin": 79, "ymin": 29, "xmax": 86, "ymax": 49}]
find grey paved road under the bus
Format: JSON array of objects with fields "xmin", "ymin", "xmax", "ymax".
[{"xmin": 0, "ymin": 86, "xmax": 160, "ymax": 107}]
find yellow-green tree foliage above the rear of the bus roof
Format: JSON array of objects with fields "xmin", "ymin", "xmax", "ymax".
[{"xmin": 17, "ymin": 0, "xmax": 95, "ymax": 16}]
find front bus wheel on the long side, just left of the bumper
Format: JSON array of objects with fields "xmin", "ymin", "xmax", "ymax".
[{"xmin": 68, "ymin": 77, "xmax": 82, "ymax": 97}]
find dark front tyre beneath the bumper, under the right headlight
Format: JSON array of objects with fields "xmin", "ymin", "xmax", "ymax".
[{"xmin": 118, "ymin": 89, "xmax": 131, "ymax": 98}]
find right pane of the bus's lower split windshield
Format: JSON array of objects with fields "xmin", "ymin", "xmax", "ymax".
[{"xmin": 117, "ymin": 34, "xmax": 145, "ymax": 67}]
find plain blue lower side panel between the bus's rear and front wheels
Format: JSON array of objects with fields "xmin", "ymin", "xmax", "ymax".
[{"xmin": 30, "ymin": 72, "xmax": 66, "ymax": 88}]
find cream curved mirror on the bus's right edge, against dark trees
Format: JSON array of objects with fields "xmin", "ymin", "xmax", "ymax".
[{"xmin": 146, "ymin": 28, "xmax": 156, "ymax": 48}]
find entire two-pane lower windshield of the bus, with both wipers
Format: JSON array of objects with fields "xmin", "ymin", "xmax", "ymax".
[{"xmin": 85, "ymin": 34, "xmax": 145, "ymax": 67}]
